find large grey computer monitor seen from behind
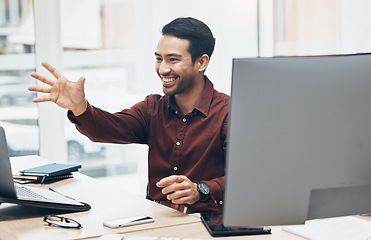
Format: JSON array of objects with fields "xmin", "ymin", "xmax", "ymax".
[{"xmin": 224, "ymin": 54, "xmax": 371, "ymax": 226}]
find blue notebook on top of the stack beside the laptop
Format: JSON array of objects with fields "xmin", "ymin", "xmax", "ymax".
[{"xmin": 19, "ymin": 163, "xmax": 81, "ymax": 177}]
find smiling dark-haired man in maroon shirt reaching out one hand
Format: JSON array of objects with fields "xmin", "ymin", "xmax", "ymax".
[{"xmin": 29, "ymin": 18, "xmax": 229, "ymax": 213}]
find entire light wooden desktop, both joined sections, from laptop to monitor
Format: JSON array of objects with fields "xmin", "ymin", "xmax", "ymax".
[{"xmin": 0, "ymin": 157, "xmax": 371, "ymax": 240}]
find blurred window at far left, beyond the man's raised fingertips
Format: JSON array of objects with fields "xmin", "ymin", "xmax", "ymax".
[{"xmin": 0, "ymin": 0, "xmax": 39, "ymax": 156}]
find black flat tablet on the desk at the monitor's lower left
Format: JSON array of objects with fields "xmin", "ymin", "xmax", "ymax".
[{"xmin": 201, "ymin": 212, "xmax": 271, "ymax": 237}]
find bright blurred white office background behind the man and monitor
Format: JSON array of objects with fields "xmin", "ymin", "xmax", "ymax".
[{"xmin": 0, "ymin": 0, "xmax": 371, "ymax": 195}]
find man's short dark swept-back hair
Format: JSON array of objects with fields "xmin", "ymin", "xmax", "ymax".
[{"xmin": 162, "ymin": 17, "xmax": 215, "ymax": 63}]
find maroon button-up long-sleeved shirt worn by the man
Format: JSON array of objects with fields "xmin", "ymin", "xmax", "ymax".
[{"xmin": 68, "ymin": 77, "xmax": 229, "ymax": 211}]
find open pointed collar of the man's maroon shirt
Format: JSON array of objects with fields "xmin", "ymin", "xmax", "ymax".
[{"xmin": 166, "ymin": 76, "xmax": 214, "ymax": 116}]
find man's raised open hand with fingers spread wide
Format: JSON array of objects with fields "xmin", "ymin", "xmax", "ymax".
[{"xmin": 28, "ymin": 62, "xmax": 87, "ymax": 116}]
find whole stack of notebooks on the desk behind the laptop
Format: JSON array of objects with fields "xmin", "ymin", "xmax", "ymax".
[{"xmin": 13, "ymin": 163, "xmax": 81, "ymax": 184}]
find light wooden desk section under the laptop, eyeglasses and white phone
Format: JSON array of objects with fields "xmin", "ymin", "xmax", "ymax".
[{"xmin": 0, "ymin": 157, "xmax": 199, "ymax": 240}]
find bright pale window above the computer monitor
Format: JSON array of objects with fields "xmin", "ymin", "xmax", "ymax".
[{"xmin": 274, "ymin": 0, "xmax": 371, "ymax": 56}]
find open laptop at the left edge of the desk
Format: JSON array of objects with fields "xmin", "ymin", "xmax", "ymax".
[{"xmin": 0, "ymin": 126, "xmax": 91, "ymax": 211}]
